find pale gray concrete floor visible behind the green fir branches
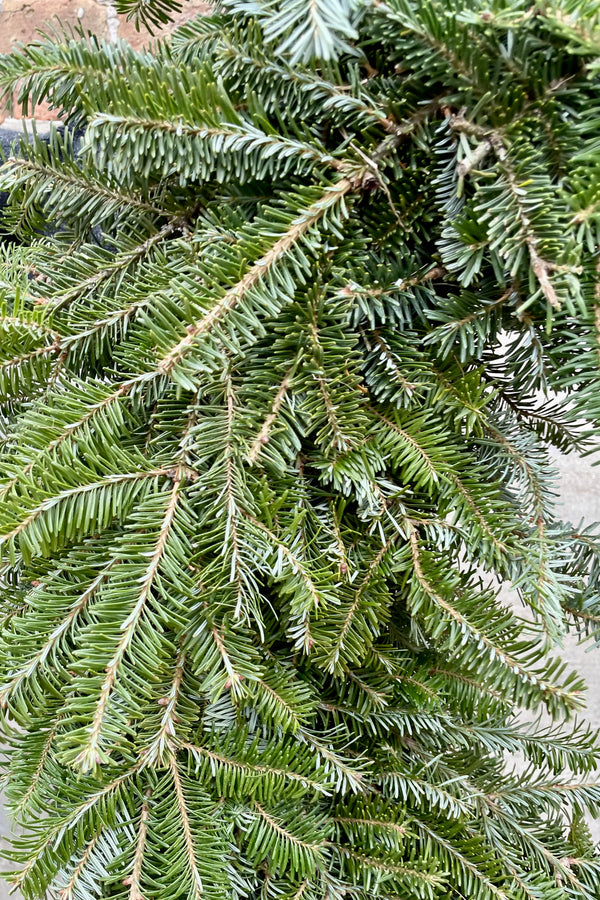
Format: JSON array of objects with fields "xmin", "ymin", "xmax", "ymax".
[{"xmin": 0, "ymin": 456, "xmax": 600, "ymax": 888}]
